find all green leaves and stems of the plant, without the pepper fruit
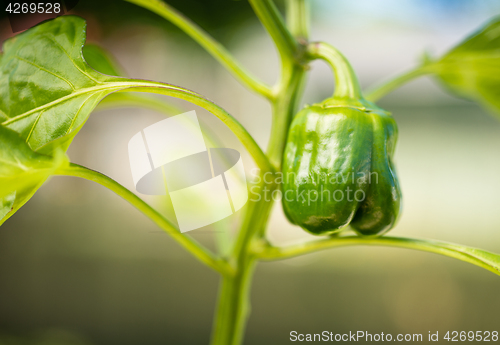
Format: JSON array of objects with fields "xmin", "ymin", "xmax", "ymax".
[{"xmin": 0, "ymin": 0, "xmax": 500, "ymax": 344}]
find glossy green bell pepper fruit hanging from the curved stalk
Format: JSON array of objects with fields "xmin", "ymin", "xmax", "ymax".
[{"xmin": 282, "ymin": 98, "xmax": 401, "ymax": 236}]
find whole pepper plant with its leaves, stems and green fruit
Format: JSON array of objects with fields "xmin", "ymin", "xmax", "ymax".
[{"xmin": 0, "ymin": 0, "xmax": 500, "ymax": 345}]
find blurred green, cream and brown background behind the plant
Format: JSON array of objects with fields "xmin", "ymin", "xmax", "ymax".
[{"xmin": 0, "ymin": 0, "xmax": 500, "ymax": 345}]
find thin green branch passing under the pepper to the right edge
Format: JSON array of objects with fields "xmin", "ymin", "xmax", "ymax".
[{"xmin": 255, "ymin": 236, "xmax": 500, "ymax": 275}]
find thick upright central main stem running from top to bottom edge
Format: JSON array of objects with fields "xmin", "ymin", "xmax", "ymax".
[{"xmin": 211, "ymin": 0, "xmax": 307, "ymax": 345}]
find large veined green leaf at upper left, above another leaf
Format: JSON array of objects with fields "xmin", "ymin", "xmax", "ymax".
[{"xmin": 0, "ymin": 16, "xmax": 121, "ymax": 155}]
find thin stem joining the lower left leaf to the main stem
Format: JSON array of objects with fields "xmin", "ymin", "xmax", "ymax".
[{"xmin": 55, "ymin": 163, "xmax": 234, "ymax": 276}]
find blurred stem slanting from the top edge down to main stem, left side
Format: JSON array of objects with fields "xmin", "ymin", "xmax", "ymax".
[{"xmin": 125, "ymin": 0, "xmax": 273, "ymax": 99}]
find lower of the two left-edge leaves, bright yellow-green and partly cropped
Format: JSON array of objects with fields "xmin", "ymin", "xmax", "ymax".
[{"xmin": 0, "ymin": 126, "xmax": 68, "ymax": 225}]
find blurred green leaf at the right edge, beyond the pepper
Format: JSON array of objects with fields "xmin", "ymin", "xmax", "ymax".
[{"xmin": 429, "ymin": 17, "xmax": 500, "ymax": 115}]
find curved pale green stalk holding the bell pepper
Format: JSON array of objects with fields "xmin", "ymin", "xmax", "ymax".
[{"xmin": 307, "ymin": 42, "xmax": 363, "ymax": 100}]
